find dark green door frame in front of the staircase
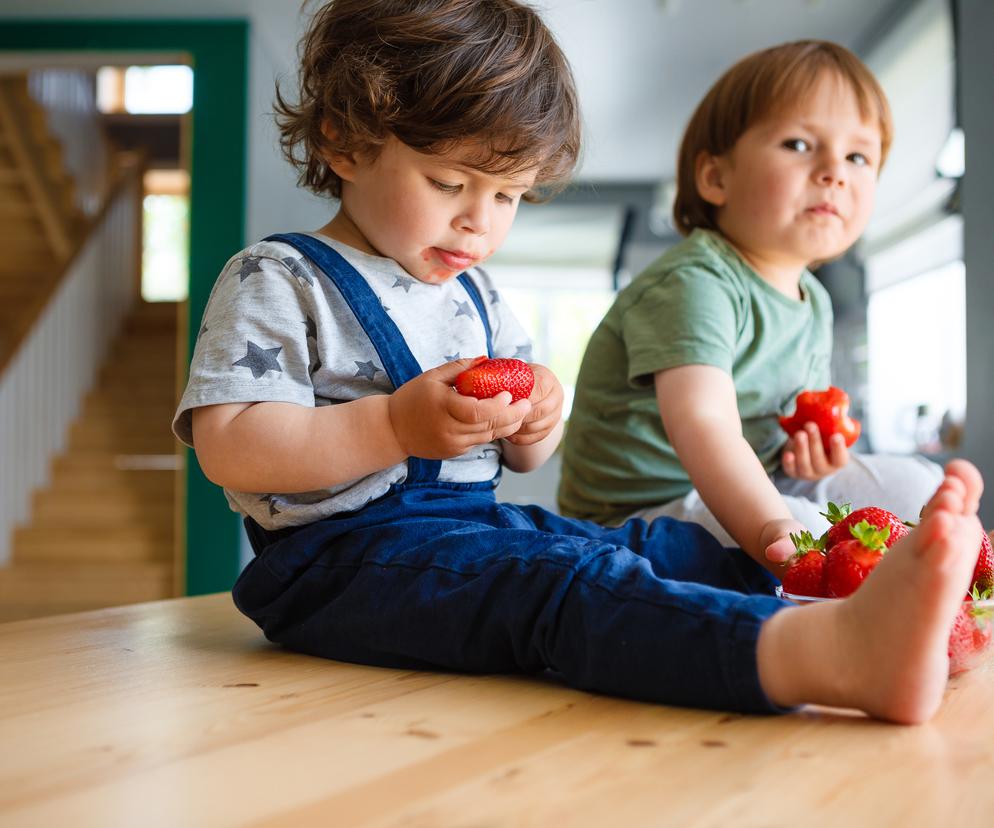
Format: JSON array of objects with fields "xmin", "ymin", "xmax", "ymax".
[{"xmin": 0, "ymin": 17, "xmax": 249, "ymax": 595}]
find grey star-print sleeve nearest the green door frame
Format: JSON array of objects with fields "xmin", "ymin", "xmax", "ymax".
[{"xmin": 173, "ymin": 250, "xmax": 315, "ymax": 446}]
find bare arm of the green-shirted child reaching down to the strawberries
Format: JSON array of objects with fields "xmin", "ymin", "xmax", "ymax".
[{"xmin": 655, "ymin": 365, "xmax": 804, "ymax": 574}]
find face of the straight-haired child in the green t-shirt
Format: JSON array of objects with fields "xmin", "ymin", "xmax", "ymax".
[{"xmin": 702, "ymin": 74, "xmax": 881, "ymax": 271}]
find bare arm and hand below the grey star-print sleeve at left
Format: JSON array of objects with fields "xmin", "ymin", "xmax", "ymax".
[{"xmin": 193, "ymin": 360, "xmax": 531, "ymax": 493}]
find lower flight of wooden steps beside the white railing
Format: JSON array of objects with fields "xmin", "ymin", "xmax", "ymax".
[{"xmin": 0, "ymin": 302, "xmax": 182, "ymax": 621}]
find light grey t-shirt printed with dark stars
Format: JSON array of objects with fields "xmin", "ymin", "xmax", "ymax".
[{"xmin": 173, "ymin": 234, "xmax": 531, "ymax": 529}]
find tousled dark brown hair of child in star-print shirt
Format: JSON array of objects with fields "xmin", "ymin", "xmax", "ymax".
[{"xmin": 275, "ymin": 0, "xmax": 580, "ymax": 201}]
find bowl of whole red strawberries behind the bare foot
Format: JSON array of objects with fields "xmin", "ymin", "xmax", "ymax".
[{"xmin": 776, "ymin": 503, "xmax": 994, "ymax": 675}]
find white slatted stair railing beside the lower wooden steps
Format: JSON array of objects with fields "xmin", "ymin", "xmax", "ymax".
[{"xmin": 0, "ymin": 168, "xmax": 141, "ymax": 565}]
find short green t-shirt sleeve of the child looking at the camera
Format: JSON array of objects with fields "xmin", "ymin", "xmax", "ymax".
[{"xmin": 620, "ymin": 266, "xmax": 739, "ymax": 387}]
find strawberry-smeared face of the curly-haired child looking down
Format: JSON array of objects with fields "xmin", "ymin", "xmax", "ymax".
[{"xmin": 333, "ymin": 137, "xmax": 536, "ymax": 284}]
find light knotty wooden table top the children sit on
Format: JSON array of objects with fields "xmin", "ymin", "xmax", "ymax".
[{"xmin": 0, "ymin": 594, "xmax": 994, "ymax": 828}]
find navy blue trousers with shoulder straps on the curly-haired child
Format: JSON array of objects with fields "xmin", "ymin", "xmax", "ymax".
[{"xmin": 233, "ymin": 234, "xmax": 785, "ymax": 712}]
